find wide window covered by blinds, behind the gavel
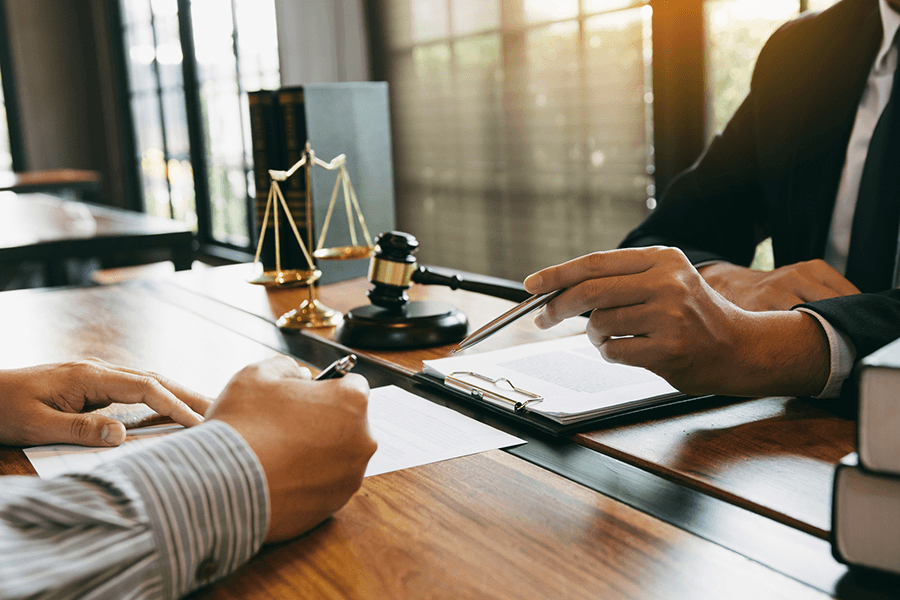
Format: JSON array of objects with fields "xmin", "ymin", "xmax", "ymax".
[{"xmin": 378, "ymin": 0, "xmax": 656, "ymax": 279}]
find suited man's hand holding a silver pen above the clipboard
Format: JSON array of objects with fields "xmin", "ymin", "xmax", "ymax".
[{"xmin": 525, "ymin": 247, "xmax": 830, "ymax": 396}]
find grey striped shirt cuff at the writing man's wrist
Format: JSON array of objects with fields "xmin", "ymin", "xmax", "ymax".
[{"xmin": 110, "ymin": 421, "xmax": 269, "ymax": 599}]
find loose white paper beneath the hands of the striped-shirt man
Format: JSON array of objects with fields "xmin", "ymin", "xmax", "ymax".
[{"xmin": 25, "ymin": 386, "xmax": 524, "ymax": 478}]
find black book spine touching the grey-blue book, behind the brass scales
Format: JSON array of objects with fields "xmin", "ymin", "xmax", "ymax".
[{"xmin": 276, "ymin": 87, "xmax": 312, "ymax": 269}]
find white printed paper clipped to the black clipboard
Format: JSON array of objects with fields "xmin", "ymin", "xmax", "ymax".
[{"xmin": 425, "ymin": 334, "xmax": 679, "ymax": 422}]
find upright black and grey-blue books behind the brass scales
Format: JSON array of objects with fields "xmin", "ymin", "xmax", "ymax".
[{"xmin": 247, "ymin": 81, "xmax": 394, "ymax": 283}]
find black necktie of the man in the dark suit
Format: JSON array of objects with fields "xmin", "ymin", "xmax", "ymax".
[{"xmin": 846, "ymin": 42, "xmax": 900, "ymax": 292}]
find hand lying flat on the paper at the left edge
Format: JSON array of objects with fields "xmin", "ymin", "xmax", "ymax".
[{"xmin": 0, "ymin": 359, "xmax": 211, "ymax": 446}]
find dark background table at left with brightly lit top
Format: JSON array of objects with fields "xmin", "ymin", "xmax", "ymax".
[{"xmin": 0, "ymin": 192, "xmax": 193, "ymax": 285}]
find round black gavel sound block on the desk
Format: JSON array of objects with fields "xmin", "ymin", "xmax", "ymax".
[{"xmin": 335, "ymin": 301, "xmax": 469, "ymax": 348}]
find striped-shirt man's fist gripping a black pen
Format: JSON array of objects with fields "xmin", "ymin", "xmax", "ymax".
[{"xmin": 206, "ymin": 356, "xmax": 377, "ymax": 542}]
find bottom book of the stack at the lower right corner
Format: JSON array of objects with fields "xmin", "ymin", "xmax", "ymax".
[{"xmin": 831, "ymin": 453, "xmax": 900, "ymax": 574}]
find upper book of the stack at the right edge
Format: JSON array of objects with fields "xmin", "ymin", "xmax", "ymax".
[{"xmin": 857, "ymin": 340, "xmax": 900, "ymax": 474}]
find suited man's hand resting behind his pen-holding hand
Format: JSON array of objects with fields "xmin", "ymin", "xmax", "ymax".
[{"xmin": 698, "ymin": 259, "xmax": 859, "ymax": 311}]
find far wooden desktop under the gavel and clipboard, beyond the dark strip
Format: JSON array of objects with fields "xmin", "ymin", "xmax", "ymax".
[{"xmin": 165, "ymin": 265, "xmax": 855, "ymax": 539}]
